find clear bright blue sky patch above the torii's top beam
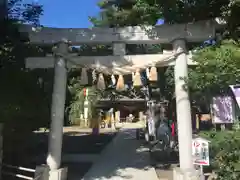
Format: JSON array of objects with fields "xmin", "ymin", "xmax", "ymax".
[{"xmin": 33, "ymin": 0, "xmax": 163, "ymax": 28}]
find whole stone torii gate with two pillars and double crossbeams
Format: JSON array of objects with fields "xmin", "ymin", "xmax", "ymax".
[{"xmin": 20, "ymin": 21, "xmax": 215, "ymax": 180}]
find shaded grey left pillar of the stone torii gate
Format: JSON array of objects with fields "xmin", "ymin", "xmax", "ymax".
[{"xmin": 47, "ymin": 42, "xmax": 68, "ymax": 180}]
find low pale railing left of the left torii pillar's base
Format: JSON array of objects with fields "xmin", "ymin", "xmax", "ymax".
[{"xmin": 2, "ymin": 164, "xmax": 36, "ymax": 180}]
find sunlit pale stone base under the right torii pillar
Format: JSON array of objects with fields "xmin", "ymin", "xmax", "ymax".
[{"xmin": 173, "ymin": 168, "xmax": 201, "ymax": 180}]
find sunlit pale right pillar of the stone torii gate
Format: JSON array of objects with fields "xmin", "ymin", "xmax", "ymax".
[{"xmin": 173, "ymin": 39, "xmax": 193, "ymax": 170}]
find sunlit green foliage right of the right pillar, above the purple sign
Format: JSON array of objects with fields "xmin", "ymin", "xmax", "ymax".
[{"xmin": 189, "ymin": 41, "xmax": 240, "ymax": 97}]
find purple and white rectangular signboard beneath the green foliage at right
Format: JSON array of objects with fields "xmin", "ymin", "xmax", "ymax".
[{"xmin": 211, "ymin": 96, "xmax": 235, "ymax": 124}]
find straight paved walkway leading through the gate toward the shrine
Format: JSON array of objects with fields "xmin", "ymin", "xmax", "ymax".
[{"xmin": 81, "ymin": 129, "xmax": 158, "ymax": 180}]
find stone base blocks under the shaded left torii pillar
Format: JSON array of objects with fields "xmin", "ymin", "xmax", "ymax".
[{"xmin": 34, "ymin": 165, "xmax": 68, "ymax": 180}]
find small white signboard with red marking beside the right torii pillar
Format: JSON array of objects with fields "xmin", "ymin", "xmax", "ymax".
[{"xmin": 192, "ymin": 138, "xmax": 209, "ymax": 166}]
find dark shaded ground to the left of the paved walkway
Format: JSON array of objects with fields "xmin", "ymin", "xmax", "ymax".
[{"xmin": 3, "ymin": 132, "xmax": 115, "ymax": 180}]
